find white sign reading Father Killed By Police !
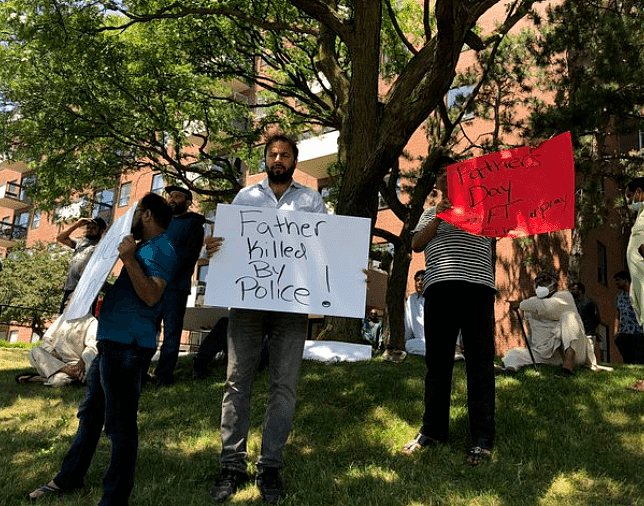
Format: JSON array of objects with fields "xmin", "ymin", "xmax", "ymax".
[{"xmin": 204, "ymin": 204, "xmax": 371, "ymax": 318}]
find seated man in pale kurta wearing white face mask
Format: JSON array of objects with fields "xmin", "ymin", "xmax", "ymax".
[{"xmin": 502, "ymin": 271, "xmax": 603, "ymax": 377}]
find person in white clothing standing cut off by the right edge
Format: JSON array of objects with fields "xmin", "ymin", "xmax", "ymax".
[{"xmin": 626, "ymin": 177, "xmax": 644, "ymax": 326}]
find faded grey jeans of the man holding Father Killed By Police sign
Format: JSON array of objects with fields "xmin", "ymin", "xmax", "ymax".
[{"xmin": 220, "ymin": 309, "xmax": 308, "ymax": 471}]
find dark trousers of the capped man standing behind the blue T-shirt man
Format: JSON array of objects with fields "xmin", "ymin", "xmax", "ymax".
[{"xmin": 154, "ymin": 290, "xmax": 189, "ymax": 383}]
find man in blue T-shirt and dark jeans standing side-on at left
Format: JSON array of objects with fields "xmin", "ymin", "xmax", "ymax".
[{"xmin": 28, "ymin": 193, "xmax": 176, "ymax": 506}]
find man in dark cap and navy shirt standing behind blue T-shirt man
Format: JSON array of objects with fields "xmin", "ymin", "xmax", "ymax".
[{"xmin": 154, "ymin": 186, "xmax": 206, "ymax": 387}]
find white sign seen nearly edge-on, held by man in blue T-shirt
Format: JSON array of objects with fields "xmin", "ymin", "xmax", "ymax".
[{"xmin": 65, "ymin": 203, "xmax": 137, "ymax": 320}]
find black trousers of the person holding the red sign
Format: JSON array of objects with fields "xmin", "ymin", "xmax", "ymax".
[{"xmin": 420, "ymin": 281, "xmax": 495, "ymax": 448}]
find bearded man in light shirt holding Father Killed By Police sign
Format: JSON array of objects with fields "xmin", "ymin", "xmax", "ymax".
[{"xmin": 206, "ymin": 134, "xmax": 326, "ymax": 503}]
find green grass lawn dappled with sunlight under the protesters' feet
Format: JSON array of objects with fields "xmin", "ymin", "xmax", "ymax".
[{"xmin": 0, "ymin": 349, "xmax": 644, "ymax": 506}]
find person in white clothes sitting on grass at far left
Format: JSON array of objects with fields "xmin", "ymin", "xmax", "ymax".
[{"xmin": 29, "ymin": 313, "xmax": 98, "ymax": 387}]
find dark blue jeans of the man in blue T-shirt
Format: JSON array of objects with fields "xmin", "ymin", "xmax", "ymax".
[{"xmin": 54, "ymin": 341, "xmax": 154, "ymax": 506}]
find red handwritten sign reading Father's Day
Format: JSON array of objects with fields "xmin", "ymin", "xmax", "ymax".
[{"xmin": 439, "ymin": 132, "xmax": 575, "ymax": 237}]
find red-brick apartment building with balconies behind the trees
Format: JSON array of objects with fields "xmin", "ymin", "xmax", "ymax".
[{"xmin": 0, "ymin": 2, "xmax": 643, "ymax": 362}]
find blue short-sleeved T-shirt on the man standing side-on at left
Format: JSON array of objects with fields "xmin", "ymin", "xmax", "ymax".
[{"xmin": 97, "ymin": 234, "xmax": 177, "ymax": 348}]
